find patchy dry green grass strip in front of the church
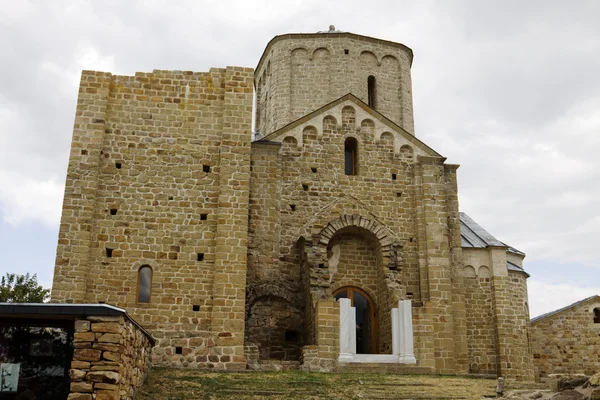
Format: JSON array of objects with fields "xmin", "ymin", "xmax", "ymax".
[{"xmin": 136, "ymin": 368, "xmax": 532, "ymax": 400}]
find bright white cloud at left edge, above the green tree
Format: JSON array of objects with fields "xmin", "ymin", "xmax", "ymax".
[{"xmin": 0, "ymin": 170, "xmax": 64, "ymax": 228}]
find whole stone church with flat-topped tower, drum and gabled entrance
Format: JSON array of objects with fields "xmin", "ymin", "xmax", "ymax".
[{"xmin": 52, "ymin": 29, "xmax": 533, "ymax": 380}]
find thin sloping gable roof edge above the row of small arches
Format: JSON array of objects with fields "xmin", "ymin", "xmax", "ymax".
[{"xmin": 254, "ymin": 93, "xmax": 442, "ymax": 157}]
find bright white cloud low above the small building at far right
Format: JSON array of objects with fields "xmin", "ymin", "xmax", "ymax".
[{"xmin": 527, "ymin": 278, "xmax": 600, "ymax": 318}]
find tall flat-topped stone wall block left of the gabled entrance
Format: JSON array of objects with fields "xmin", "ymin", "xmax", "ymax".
[{"xmin": 52, "ymin": 67, "xmax": 253, "ymax": 369}]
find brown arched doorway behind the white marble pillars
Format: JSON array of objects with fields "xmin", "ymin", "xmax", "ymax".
[{"xmin": 333, "ymin": 286, "xmax": 379, "ymax": 354}]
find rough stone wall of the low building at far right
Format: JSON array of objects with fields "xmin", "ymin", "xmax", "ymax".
[{"xmin": 531, "ymin": 297, "xmax": 600, "ymax": 379}]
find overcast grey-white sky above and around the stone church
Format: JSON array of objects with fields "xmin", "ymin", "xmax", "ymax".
[{"xmin": 0, "ymin": 0, "xmax": 600, "ymax": 316}]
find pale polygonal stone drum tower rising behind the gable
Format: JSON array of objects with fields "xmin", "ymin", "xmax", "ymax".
[{"xmin": 255, "ymin": 33, "xmax": 414, "ymax": 134}]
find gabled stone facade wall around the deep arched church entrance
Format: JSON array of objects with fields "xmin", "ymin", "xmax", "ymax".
[{"xmin": 248, "ymin": 97, "xmax": 467, "ymax": 373}]
